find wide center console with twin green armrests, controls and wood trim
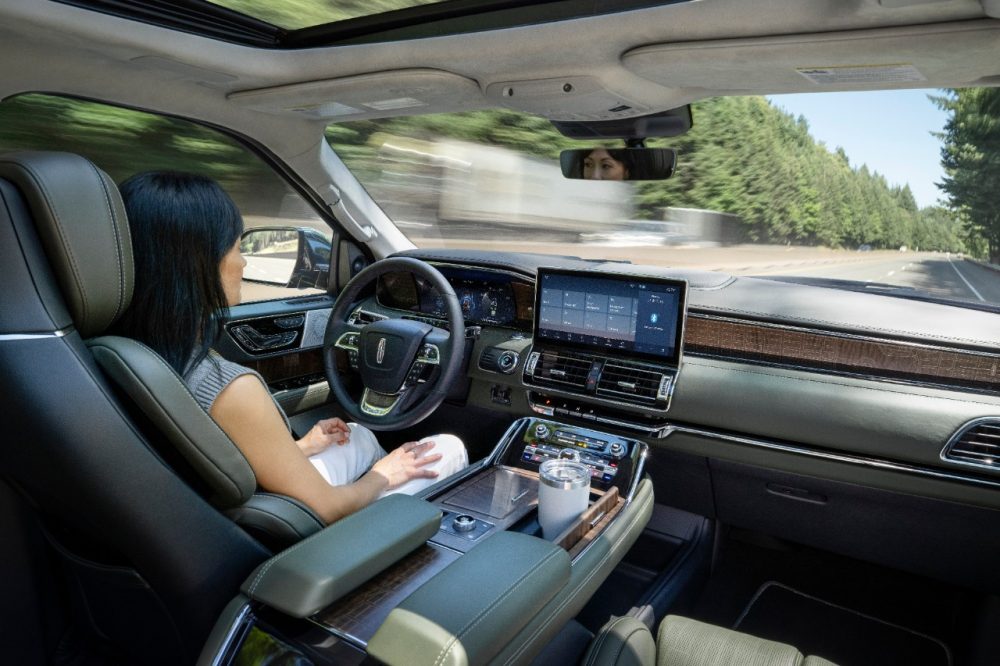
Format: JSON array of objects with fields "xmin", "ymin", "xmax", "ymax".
[{"xmin": 203, "ymin": 417, "xmax": 653, "ymax": 665}]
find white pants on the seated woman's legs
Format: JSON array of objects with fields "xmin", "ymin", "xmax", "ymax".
[{"xmin": 309, "ymin": 423, "xmax": 469, "ymax": 495}]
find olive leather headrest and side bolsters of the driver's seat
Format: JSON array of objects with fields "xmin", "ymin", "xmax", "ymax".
[{"xmin": 0, "ymin": 151, "xmax": 323, "ymax": 547}]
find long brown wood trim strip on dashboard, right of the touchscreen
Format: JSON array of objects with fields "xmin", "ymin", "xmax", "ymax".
[{"xmin": 684, "ymin": 315, "xmax": 1000, "ymax": 392}]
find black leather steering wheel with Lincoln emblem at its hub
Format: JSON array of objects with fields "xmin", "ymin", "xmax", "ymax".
[{"xmin": 323, "ymin": 257, "xmax": 465, "ymax": 430}]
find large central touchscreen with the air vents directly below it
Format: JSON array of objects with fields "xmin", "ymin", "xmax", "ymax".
[{"xmin": 523, "ymin": 268, "xmax": 687, "ymax": 431}]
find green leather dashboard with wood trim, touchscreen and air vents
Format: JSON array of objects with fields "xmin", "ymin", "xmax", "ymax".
[{"xmin": 363, "ymin": 250, "xmax": 1000, "ymax": 503}]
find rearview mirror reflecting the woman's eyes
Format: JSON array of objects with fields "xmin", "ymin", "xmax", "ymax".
[{"xmin": 559, "ymin": 146, "xmax": 677, "ymax": 180}]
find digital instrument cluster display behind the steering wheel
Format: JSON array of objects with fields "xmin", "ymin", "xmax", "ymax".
[{"xmin": 376, "ymin": 268, "xmax": 533, "ymax": 329}]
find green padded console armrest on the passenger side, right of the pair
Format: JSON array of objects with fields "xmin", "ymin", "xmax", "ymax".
[{"xmin": 368, "ymin": 532, "xmax": 570, "ymax": 666}]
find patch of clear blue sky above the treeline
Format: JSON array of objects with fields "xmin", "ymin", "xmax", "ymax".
[{"xmin": 768, "ymin": 90, "xmax": 948, "ymax": 207}]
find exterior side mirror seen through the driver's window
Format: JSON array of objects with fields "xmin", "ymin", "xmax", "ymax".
[{"xmin": 240, "ymin": 227, "xmax": 331, "ymax": 289}]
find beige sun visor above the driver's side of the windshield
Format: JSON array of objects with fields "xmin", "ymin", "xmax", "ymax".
[{"xmin": 229, "ymin": 69, "xmax": 485, "ymax": 122}]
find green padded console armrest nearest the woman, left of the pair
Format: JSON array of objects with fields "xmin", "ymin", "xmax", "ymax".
[{"xmin": 241, "ymin": 494, "xmax": 441, "ymax": 617}]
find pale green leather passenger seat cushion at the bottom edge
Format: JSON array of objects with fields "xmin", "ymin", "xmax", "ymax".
[{"xmin": 582, "ymin": 615, "xmax": 835, "ymax": 666}]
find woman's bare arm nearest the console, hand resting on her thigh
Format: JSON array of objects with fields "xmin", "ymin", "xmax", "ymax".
[{"xmin": 209, "ymin": 375, "xmax": 441, "ymax": 523}]
